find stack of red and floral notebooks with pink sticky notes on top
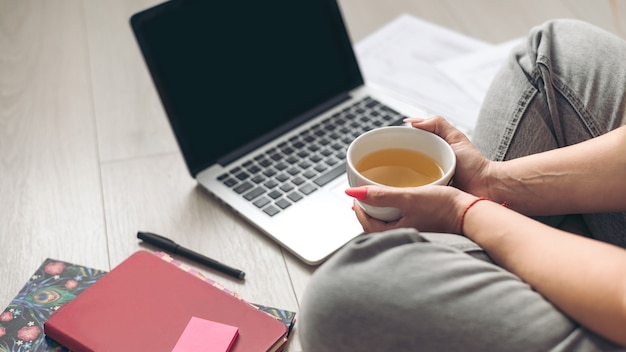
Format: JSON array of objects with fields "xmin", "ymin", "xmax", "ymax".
[{"xmin": 0, "ymin": 251, "xmax": 295, "ymax": 352}]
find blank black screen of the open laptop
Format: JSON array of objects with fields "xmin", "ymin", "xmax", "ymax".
[{"xmin": 131, "ymin": 0, "xmax": 363, "ymax": 176}]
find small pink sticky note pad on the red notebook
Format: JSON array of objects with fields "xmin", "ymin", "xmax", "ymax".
[{"xmin": 172, "ymin": 317, "xmax": 239, "ymax": 352}]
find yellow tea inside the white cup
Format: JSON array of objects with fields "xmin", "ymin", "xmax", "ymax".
[{"xmin": 355, "ymin": 148, "xmax": 443, "ymax": 187}]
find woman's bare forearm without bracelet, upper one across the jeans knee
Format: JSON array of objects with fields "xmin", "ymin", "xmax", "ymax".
[{"xmin": 488, "ymin": 127, "xmax": 626, "ymax": 216}]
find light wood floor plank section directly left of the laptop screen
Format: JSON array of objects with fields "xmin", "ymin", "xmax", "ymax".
[{"xmin": 84, "ymin": 0, "xmax": 178, "ymax": 161}]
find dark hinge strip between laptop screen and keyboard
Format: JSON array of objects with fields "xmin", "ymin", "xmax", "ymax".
[{"xmin": 217, "ymin": 93, "xmax": 350, "ymax": 166}]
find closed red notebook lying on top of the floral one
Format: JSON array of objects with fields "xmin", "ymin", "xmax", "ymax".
[{"xmin": 44, "ymin": 251, "xmax": 288, "ymax": 352}]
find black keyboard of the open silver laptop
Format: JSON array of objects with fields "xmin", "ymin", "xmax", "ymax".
[{"xmin": 218, "ymin": 97, "xmax": 405, "ymax": 216}]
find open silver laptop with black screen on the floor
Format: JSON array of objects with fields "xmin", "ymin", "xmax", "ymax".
[{"xmin": 130, "ymin": 0, "xmax": 424, "ymax": 265}]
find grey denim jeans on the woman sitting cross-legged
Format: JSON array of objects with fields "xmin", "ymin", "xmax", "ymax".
[{"xmin": 297, "ymin": 20, "xmax": 626, "ymax": 352}]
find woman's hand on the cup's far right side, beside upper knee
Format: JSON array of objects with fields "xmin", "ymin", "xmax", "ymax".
[{"xmin": 405, "ymin": 116, "xmax": 493, "ymax": 197}]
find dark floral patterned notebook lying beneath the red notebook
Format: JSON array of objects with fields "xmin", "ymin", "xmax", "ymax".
[{"xmin": 0, "ymin": 252, "xmax": 296, "ymax": 352}]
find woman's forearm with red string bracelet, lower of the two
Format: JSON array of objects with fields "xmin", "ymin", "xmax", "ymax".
[{"xmin": 462, "ymin": 201, "xmax": 626, "ymax": 346}]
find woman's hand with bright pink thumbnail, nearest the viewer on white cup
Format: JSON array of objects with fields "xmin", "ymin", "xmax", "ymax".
[{"xmin": 346, "ymin": 185, "xmax": 476, "ymax": 233}]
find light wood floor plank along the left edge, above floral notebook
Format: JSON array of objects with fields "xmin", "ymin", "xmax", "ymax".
[{"xmin": 0, "ymin": 0, "xmax": 109, "ymax": 308}]
